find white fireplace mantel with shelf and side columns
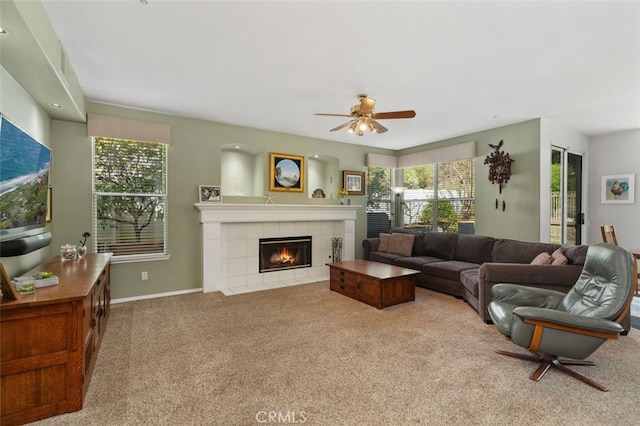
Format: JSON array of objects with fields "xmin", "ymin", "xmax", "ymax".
[{"xmin": 194, "ymin": 203, "xmax": 361, "ymax": 294}]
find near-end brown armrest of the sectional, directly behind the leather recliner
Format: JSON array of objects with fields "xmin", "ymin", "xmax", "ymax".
[{"xmin": 478, "ymin": 263, "xmax": 582, "ymax": 322}]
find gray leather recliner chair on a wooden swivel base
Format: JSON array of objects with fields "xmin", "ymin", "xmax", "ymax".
[{"xmin": 488, "ymin": 243, "xmax": 637, "ymax": 391}]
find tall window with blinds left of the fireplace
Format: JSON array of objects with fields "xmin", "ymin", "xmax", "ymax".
[{"xmin": 93, "ymin": 138, "xmax": 167, "ymax": 261}]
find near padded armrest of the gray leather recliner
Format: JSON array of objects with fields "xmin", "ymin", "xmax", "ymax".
[{"xmin": 513, "ymin": 306, "xmax": 624, "ymax": 334}]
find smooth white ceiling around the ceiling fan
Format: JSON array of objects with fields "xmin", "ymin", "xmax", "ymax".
[{"xmin": 44, "ymin": 0, "xmax": 640, "ymax": 149}]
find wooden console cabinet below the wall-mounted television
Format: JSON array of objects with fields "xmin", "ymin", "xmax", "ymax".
[{"xmin": 0, "ymin": 253, "xmax": 111, "ymax": 425}]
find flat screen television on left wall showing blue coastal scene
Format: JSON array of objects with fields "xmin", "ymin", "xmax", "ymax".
[{"xmin": 0, "ymin": 113, "xmax": 51, "ymax": 241}]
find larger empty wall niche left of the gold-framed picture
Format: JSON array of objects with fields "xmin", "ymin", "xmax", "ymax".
[{"xmin": 220, "ymin": 144, "xmax": 266, "ymax": 197}]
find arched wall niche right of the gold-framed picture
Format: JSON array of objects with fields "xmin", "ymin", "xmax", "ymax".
[{"xmin": 307, "ymin": 153, "xmax": 342, "ymax": 198}]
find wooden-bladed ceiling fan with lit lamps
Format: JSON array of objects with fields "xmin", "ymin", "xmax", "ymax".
[{"xmin": 314, "ymin": 95, "xmax": 416, "ymax": 136}]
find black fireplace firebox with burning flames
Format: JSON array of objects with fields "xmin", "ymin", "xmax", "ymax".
[{"xmin": 258, "ymin": 235, "xmax": 311, "ymax": 273}]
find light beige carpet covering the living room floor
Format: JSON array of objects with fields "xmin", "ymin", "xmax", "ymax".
[{"xmin": 31, "ymin": 282, "xmax": 640, "ymax": 425}]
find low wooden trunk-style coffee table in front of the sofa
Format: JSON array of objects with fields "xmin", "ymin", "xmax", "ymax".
[{"xmin": 327, "ymin": 259, "xmax": 420, "ymax": 309}]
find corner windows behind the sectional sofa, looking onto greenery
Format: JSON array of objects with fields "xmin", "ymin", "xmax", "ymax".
[{"xmin": 367, "ymin": 158, "xmax": 475, "ymax": 234}]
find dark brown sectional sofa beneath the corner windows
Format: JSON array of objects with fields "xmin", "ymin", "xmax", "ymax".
[{"xmin": 362, "ymin": 228, "xmax": 592, "ymax": 322}]
